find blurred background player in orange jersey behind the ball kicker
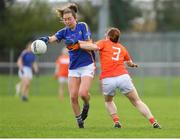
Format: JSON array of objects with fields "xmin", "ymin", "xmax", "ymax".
[{"xmin": 55, "ymin": 48, "xmax": 69, "ymax": 100}]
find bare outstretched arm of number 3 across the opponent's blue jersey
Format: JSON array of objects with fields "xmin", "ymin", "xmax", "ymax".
[{"xmin": 78, "ymin": 41, "xmax": 99, "ymax": 50}]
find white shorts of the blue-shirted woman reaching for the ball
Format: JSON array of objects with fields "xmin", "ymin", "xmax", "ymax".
[{"xmin": 68, "ymin": 63, "xmax": 95, "ymax": 77}]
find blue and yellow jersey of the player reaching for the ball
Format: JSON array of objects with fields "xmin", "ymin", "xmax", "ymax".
[{"xmin": 55, "ymin": 22, "xmax": 95, "ymax": 69}]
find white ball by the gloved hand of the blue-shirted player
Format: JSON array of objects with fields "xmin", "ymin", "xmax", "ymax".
[{"xmin": 31, "ymin": 40, "xmax": 47, "ymax": 54}]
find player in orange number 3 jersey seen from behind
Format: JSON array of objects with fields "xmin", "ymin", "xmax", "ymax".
[{"xmin": 79, "ymin": 28, "xmax": 161, "ymax": 128}]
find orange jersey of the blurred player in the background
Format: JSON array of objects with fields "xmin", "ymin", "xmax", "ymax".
[{"xmin": 56, "ymin": 55, "xmax": 69, "ymax": 77}]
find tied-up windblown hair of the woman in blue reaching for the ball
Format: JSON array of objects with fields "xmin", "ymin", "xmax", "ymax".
[{"xmin": 56, "ymin": 3, "xmax": 78, "ymax": 19}]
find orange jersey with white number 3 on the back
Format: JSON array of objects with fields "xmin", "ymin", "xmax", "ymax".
[{"xmin": 96, "ymin": 39, "xmax": 131, "ymax": 79}]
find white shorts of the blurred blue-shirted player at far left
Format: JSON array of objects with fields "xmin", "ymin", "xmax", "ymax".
[{"xmin": 18, "ymin": 66, "xmax": 33, "ymax": 80}]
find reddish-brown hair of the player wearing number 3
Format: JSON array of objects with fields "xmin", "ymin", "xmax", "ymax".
[{"xmin": 107, "ymin": 28, "xmax": 121, "ymax": 43}]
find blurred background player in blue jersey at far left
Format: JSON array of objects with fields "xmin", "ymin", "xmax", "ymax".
[{"xmin": 16, "ymin": 41, "xmax": 38, "ymax": 101}]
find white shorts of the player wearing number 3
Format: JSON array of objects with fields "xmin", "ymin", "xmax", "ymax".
[{"xmin": 101, "ymin": 74, "xmax": 134, "ymax": 96}]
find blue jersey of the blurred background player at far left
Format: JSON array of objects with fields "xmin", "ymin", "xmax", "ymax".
[{"xmin": 20, "ymin": 51, "xmax": 35, "ymax": 68}]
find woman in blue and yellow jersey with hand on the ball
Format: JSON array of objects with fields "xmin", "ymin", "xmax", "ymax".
[{"xmin": 40, "ymin": 3, "xmax": 95, "ymax": 128}]
